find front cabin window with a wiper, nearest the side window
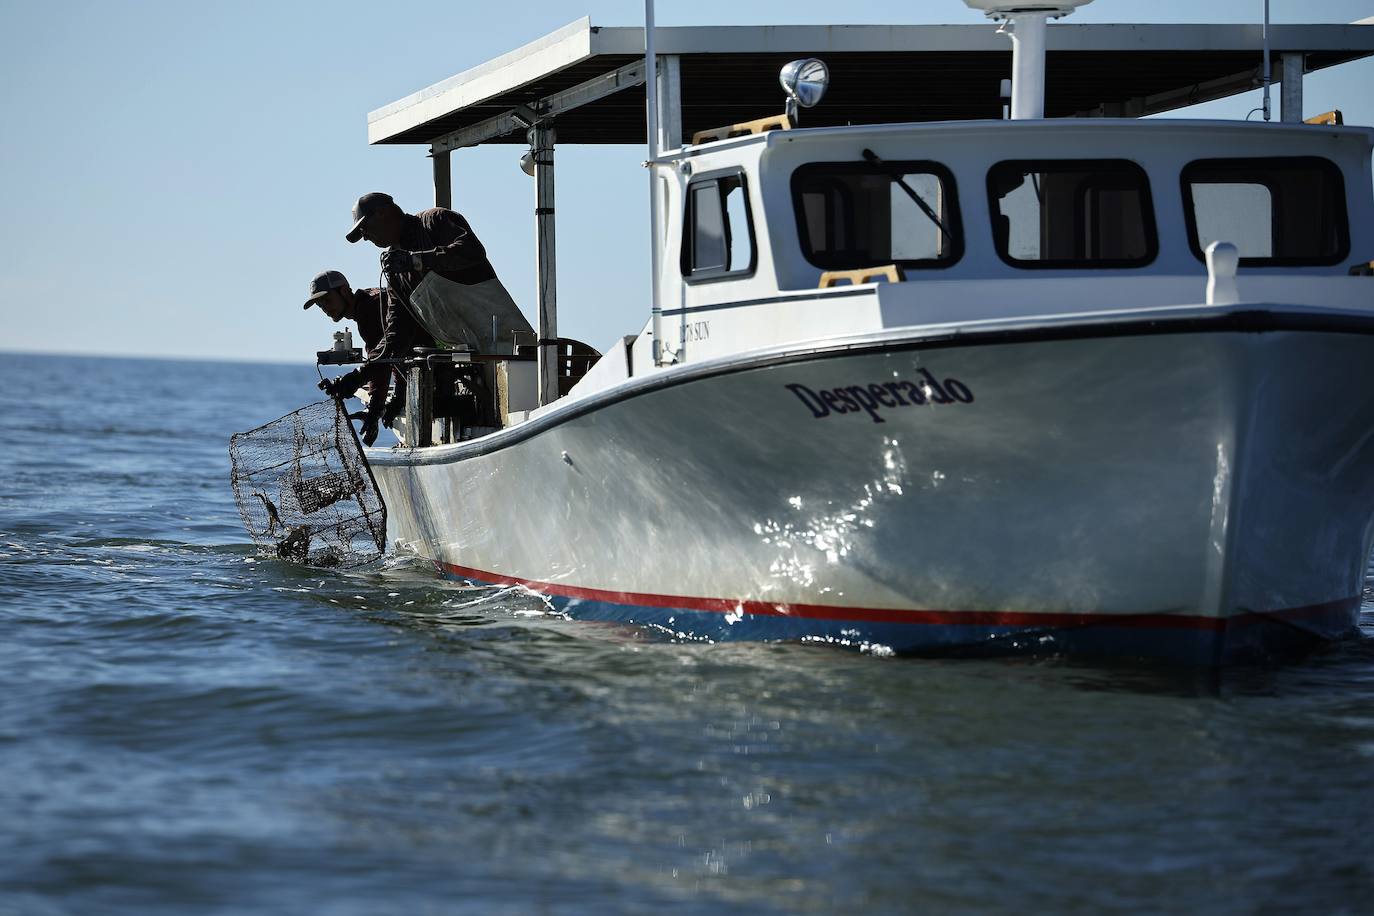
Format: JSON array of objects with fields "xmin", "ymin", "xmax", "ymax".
[{"xmin": 791, "ymin": 161, "xmax": 963, "ymax": 271}]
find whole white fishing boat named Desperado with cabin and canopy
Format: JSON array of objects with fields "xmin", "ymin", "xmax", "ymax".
[{"xmin": 343, "ymin": 0, "xmax": 1374, "ymax": 663}]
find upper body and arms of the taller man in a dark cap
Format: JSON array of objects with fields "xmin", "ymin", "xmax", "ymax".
[{"xmin": 345, "ymin": 192, "xmax": 511, "ymax": 347}]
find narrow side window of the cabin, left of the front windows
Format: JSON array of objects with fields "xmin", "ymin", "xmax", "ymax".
[{"xmin": 682, "ymin": 173, "xmax": 754, "ymax": 280}]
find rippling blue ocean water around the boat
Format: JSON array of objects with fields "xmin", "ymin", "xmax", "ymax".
[{"xmin": 8, "ymin": 353, "xmax": 1374, "ymax": 916}]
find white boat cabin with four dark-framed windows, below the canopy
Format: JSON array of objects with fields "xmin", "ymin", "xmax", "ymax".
[{"xmin": 636, "ymin": 119, "xmax": 1374, "ymax": 362}]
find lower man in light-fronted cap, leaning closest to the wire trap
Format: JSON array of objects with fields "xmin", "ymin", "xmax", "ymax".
[{"xmin": 305, "ymin": 271, "xmax": 434, "ymax": 445}]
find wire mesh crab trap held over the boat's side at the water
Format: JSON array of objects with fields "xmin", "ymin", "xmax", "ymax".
[{"xmin": 229, "ymin": 400, "xmax": 386, "ymax": 567}]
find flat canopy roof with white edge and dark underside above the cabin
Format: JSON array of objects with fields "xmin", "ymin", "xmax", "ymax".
[{"xmin": 368, "ymin": 18, "xmax": 1374, "ymax": 152}]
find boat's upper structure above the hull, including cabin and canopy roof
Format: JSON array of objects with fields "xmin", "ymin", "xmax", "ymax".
[{"xmin": 357, "ymin": 11, "xmax": 1374, "ymax": 445}]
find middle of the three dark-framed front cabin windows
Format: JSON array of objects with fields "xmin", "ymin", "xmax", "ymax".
[{"xmin": 988, "ymin": 159, "xmax": 1158, "ymax": 268}]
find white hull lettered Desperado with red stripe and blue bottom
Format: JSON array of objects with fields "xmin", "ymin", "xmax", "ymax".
[{"xmin": 370, "ymin": 313, "xmax": 1374, "ymax": 662}]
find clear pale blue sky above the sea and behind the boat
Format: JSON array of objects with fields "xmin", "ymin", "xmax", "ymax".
[{"xmin": 0, "ymin": 0, "xmax": 1374, "ymax": 361}]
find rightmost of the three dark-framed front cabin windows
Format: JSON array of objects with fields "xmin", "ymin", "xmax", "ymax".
[{"xmin": 1183, "ymin": 157, "xmax": 1351, "ymax": 266}]
